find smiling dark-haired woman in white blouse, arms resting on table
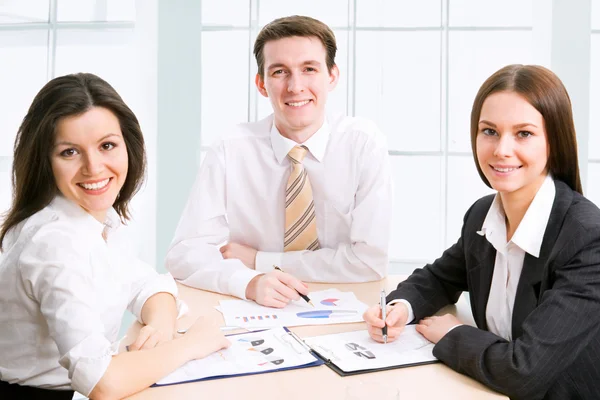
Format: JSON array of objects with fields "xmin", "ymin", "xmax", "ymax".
[{"xmin": 0, "ymin": 74, "xmax": 229, "ymax": 399}]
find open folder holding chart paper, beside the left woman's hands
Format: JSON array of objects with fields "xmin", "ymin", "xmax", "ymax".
[{"xmin": 153, "ymin": 327, "xmax": 324, "ymax": 386}]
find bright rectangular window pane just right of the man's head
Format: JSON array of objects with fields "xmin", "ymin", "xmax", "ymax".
[{"xmin": 356, "ymin": 32, "xmax": 441, "ymax": 151}]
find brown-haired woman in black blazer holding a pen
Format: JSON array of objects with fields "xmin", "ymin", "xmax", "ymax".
[{"xmin": 364, "ymin": 65, "xmax": 600, "ymax": 399}]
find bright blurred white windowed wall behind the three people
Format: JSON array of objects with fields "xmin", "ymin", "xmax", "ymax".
[{"xmin": 0, "ymin": 0, "xmax": 600, "ymax": 273}]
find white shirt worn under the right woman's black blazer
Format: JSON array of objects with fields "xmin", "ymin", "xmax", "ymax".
[{"xmin": 400, "ymin": 176, "xmax": 556, "ymax": 341}]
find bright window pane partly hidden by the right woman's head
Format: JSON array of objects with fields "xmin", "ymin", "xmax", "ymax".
[{"xmin": 448, "ymin": 32, "xmax": 533, "ymax": 151}]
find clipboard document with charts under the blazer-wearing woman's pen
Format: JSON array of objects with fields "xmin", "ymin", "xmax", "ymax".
[{"xmin": 304, "ymin": 325, "xmax": 437, "ymax": 376}]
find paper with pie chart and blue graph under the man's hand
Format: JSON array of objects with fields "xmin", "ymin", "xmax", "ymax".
[{"xmin": 220, "ymin": 289, "xmax": 368, "ymax": 328}]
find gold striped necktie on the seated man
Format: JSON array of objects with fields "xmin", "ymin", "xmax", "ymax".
[{"xmin": 283, "ymin": 146, "xmax": 319, "ymax": 251}]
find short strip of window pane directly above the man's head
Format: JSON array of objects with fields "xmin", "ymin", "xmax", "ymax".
[{"xmin": 258, "ymin": 0, "xmax": 348, "ymax": 29}]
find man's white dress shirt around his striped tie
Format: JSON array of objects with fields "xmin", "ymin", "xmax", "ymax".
[{"xmin": 166, "ymin": 112, "xmax": 392, "ymax": 298}]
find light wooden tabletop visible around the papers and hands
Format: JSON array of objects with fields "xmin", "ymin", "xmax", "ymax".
[{"xmin": 128, "ymin": 275, "xmax": 507, "ymax": 400}]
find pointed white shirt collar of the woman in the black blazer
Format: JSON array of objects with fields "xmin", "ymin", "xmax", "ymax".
[{"xmin": 477, "ymin": 175, "xmax": 556, "ymax": 257}]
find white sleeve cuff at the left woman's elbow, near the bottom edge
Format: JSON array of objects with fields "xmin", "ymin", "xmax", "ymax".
[{"xmin": 59, "ymin": 334, "xmax": 119, "ymax": 397}]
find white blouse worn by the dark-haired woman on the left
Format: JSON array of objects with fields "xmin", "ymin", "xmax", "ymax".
[{"xmin": 0, "ymin": 196, "xmax": 177, "ymax": 396}]
